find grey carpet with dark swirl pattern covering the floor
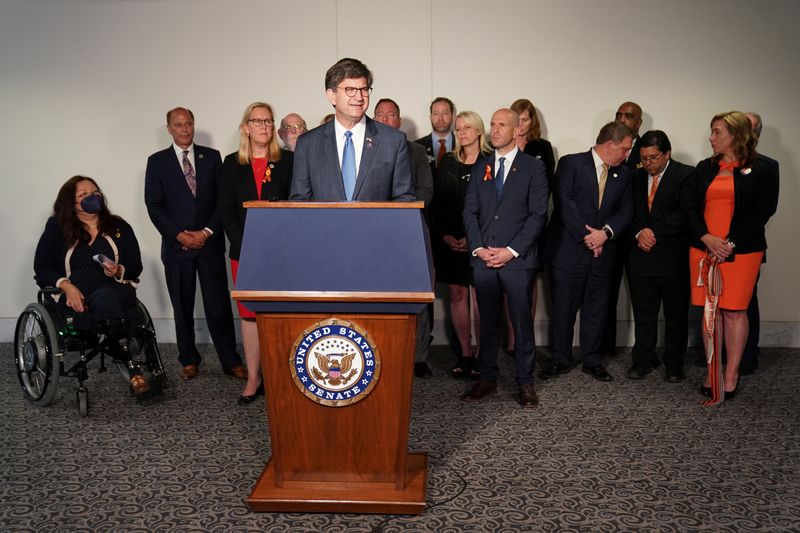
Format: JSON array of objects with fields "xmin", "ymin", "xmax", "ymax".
[{"xmin": 0, "ymin": 344, "xmax": 800, "ymax": 533}]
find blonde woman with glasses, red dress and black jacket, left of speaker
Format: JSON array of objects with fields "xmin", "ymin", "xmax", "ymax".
[{"xmin": 217, "ymin": 102, "xmax": 292, "ymax": 404}]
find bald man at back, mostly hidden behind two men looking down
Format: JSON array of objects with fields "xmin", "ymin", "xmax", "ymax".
[{"xmin": 600, "ymin": 102, "xmax": 642, "ymax": 355}]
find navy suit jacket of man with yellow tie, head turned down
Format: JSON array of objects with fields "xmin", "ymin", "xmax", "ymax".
[{"xmin": 545, "ymin": 150, "xmax": 633, "ymax": 274}]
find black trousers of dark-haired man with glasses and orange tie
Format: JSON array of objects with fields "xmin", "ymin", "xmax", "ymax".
[{"xmin": 630, "ymin": 271, "xmax": 690, "ymax": 369}]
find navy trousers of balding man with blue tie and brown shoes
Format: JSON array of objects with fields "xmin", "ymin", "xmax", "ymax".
[{"xmin": 473, "ymin": 267, "xmax": 536, "ymax": 385}]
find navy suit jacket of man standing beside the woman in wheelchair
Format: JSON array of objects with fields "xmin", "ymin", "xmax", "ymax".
[{"xmin": 144, "ymin": 144, "xmax": 225, "ymax": 263}]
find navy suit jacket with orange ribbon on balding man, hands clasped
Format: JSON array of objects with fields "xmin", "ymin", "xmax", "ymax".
[{"xmin": 464, "ymin": 152, "xmax": 549, "ymax": 269}]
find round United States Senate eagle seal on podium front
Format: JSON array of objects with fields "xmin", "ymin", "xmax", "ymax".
[{"xmin": 289, "ymin": 318, "xmax": 381, "ymax": 407}]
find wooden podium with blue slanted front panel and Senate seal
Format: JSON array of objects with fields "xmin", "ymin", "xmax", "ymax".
[{"xmin": 233, "ymin": 202, "xmax": 434, "ymax": 514}]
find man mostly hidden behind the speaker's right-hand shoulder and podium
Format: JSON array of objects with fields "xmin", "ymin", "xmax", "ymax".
[{"xmin": 374, "ymin": 98, "xmax": 433, "ymax": 378}]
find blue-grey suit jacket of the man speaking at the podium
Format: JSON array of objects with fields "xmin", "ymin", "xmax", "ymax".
[{"xmin": 289, "ymin": 117, "xmax": 416, "ymax": 202}]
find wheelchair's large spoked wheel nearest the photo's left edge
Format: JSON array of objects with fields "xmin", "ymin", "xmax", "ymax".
[{"xmin": 14, "ymin": 303, "xmax": 62, "ymax": 407}]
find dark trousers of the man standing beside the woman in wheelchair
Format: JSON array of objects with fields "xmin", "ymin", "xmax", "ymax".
[{"xmin": 164, "ymin": 254, "xmax": 242, "ymax": 368}]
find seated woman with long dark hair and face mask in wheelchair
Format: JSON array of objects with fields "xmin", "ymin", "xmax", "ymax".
[{"xmin": 33, "ymin": 176, "xmax": 150, "ymax": 395}]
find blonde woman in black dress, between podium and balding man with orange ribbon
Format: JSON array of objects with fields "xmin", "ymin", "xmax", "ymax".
[{"xmin": 431, "ymin": 111, "xmax": 491, "ymax": 377}]
